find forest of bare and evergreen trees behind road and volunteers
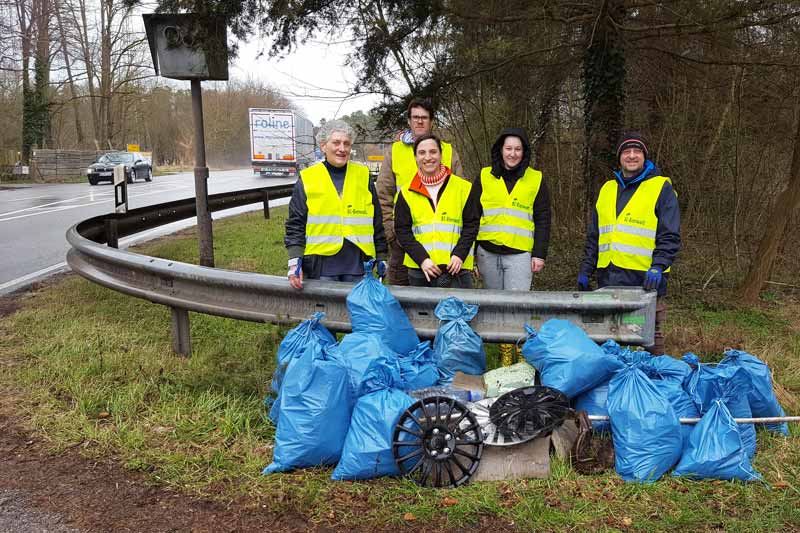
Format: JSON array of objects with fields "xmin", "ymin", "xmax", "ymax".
[{"xmin": 0, "ymin": 0, "xmax": 800, "ymax": 301}]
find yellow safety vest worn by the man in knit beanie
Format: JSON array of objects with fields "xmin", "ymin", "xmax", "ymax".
[{"xmin": 596, "ymin": 176, "xmax": 672, "ymax": 272}]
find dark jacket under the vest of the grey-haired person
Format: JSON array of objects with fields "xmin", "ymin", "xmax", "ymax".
[{"xmin": 283, "ymin": 161, "xmax": 389, "ymax": 279}]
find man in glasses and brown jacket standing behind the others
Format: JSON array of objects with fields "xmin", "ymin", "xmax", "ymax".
[{"xmin": 375, "ymin": 98, "xmax": 471, "ymax": 285}]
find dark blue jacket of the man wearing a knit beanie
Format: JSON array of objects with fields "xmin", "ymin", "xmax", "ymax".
[{"xmin": 580, "ymin": 159, "xmax": 681, "ymax": 296}]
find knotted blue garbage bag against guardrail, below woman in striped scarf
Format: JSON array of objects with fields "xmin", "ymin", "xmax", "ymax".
[{"xmin": 433, "ymin": 296, "xmax": 486, "ymax": 383}]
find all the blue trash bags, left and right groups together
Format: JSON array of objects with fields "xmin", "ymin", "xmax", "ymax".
[{"xmin": 264, "ymin": 264, "xmax": 788, "ymax": 483}]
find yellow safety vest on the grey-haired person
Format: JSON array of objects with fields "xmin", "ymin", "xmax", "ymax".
[{"xmin": 300, "ymin": 163, "xmax": 375, "ymax": 257}]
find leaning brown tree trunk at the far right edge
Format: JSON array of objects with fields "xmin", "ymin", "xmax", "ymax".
[{"xmin": 740, "ymin": 104, "xmax": 800, "ymax": 303}]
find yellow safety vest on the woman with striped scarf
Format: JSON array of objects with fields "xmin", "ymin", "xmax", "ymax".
[{"xmin": 402, "ymin": 174, "xmax": 473, "ymax": 270}]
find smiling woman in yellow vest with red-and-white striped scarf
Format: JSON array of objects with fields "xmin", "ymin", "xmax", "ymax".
[{"xmin": 394, "ymin": 134, "xmax": 480, "ymax": 289}]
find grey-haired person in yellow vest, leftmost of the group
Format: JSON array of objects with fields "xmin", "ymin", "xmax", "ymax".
[{"xmin": 284, "ymin": 120, "xmax": 388, "ymax": 289}]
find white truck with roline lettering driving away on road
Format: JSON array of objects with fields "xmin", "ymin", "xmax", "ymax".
[{"xmin": 250, "ymin": 107, "xmax": 316, "ymax": 178}]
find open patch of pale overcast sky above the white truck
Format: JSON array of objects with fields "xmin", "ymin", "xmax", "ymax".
[{"xmin": 230, "ymin": 34, "xmax": 380, "ymax": 125}]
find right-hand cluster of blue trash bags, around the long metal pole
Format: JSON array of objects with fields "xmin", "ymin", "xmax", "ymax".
[{"xmin": 522, "ymin": 320, "xmax": 788, "ymax": 483}]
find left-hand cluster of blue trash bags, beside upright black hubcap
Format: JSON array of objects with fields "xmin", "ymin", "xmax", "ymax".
[{"xmin": 264, "ymin": 264, "xmax": 486, "ymax": 480}]
